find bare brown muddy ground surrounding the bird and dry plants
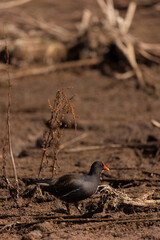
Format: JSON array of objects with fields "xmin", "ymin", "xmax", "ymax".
[{"xmin": 0, "ymin": 0, "xmax": 160, "ymax": 240}]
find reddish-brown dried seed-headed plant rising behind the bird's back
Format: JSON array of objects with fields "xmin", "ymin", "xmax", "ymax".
[{"xmin": 38, "ymin": 87, "xmax": 77, "ymax": 177}]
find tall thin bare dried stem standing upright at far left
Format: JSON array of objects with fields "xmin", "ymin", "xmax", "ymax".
[{"xmin": 6, "ymin": 43, "xmax": 19, "ymax": 197}]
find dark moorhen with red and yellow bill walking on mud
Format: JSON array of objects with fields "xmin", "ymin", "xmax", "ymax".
[{"xmin": 36, "ymin": 161, "xmax": 109, "ymax": 214}]
